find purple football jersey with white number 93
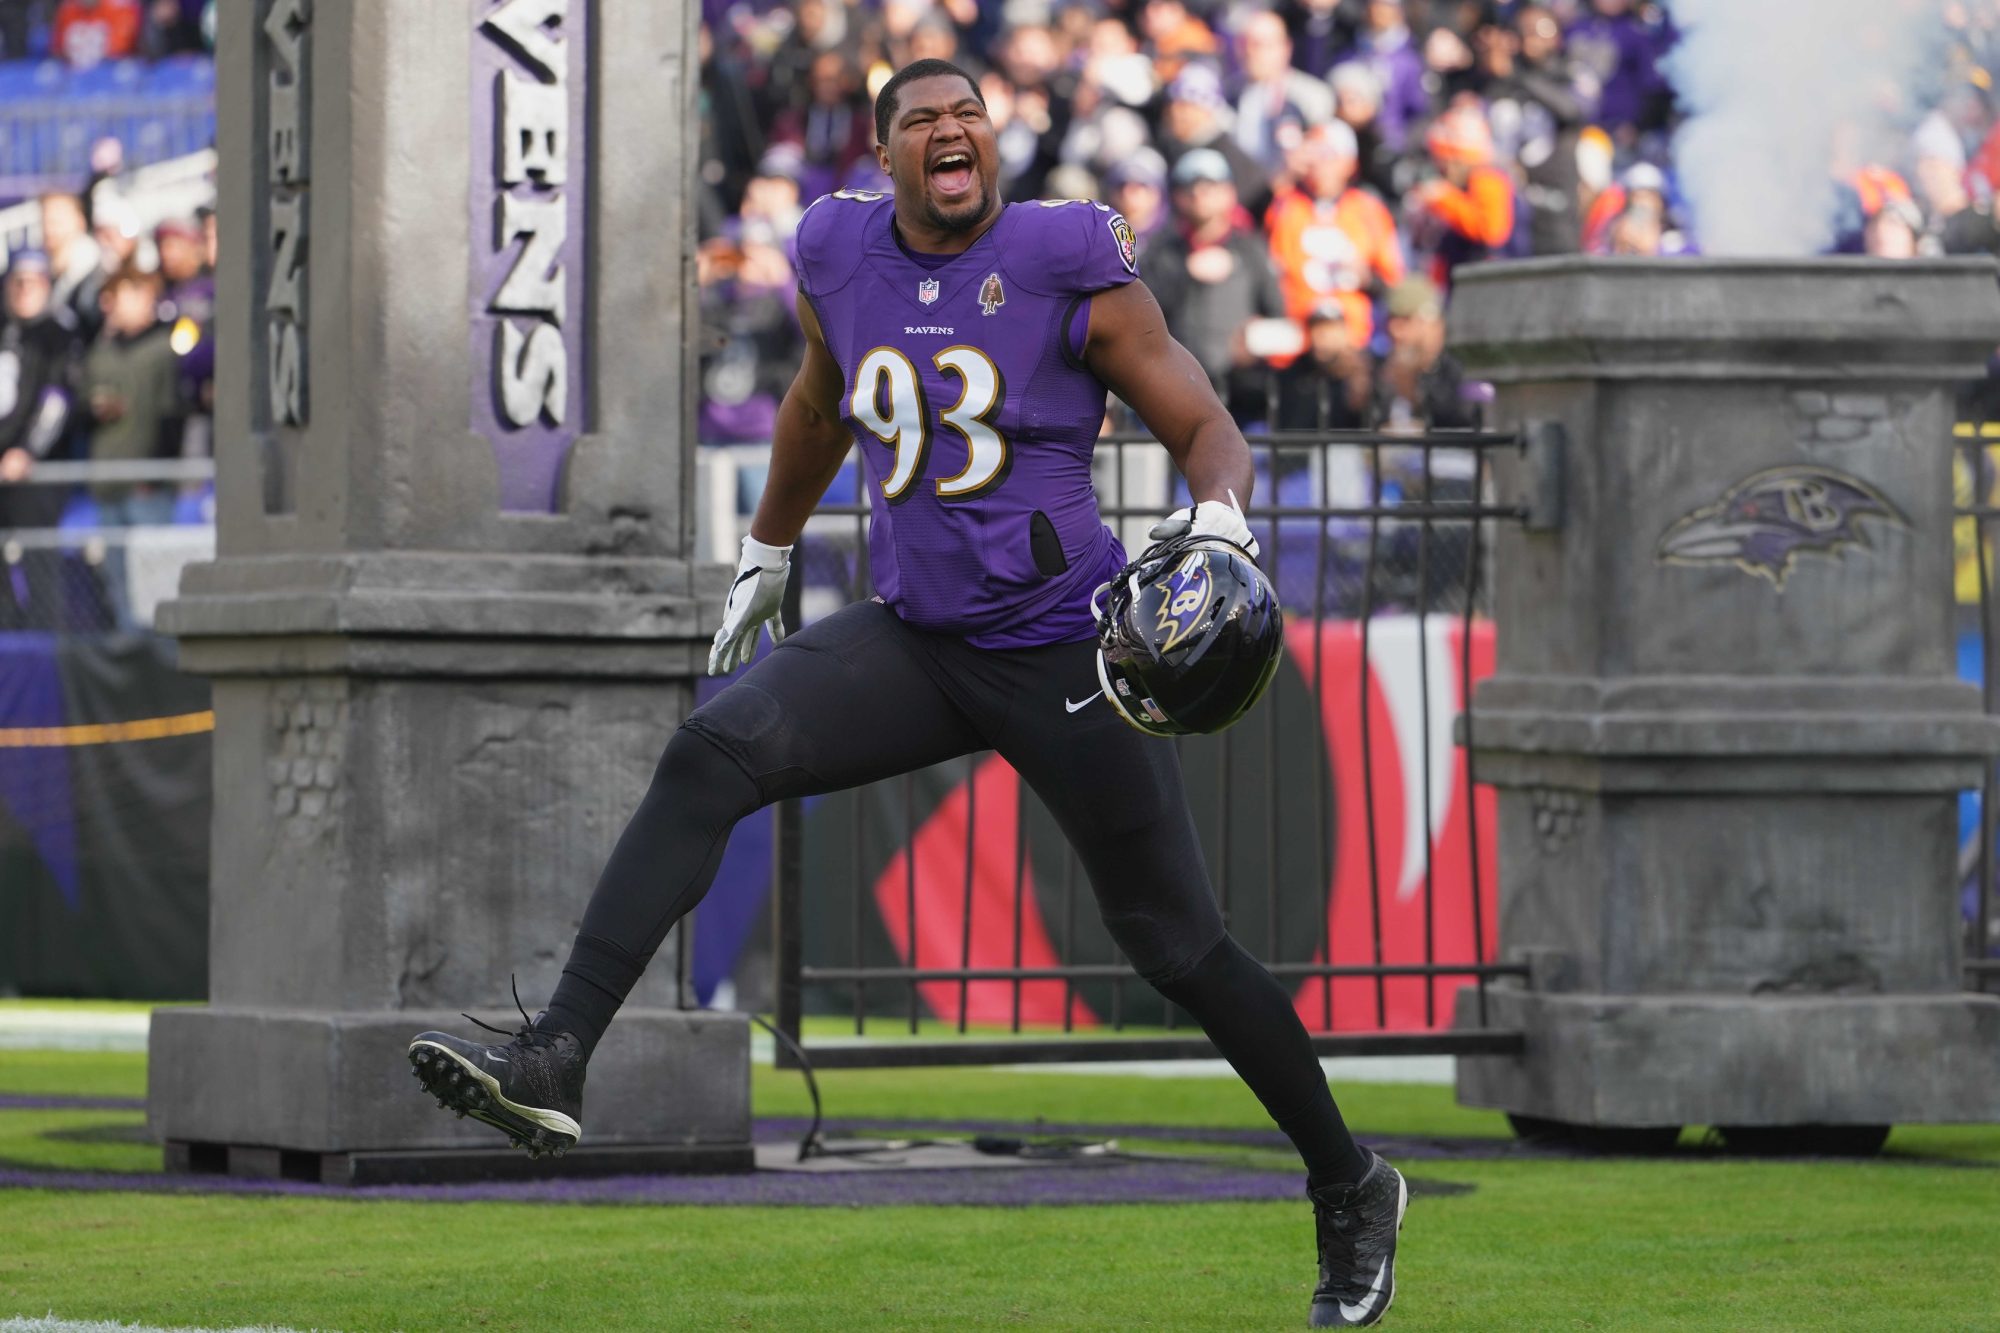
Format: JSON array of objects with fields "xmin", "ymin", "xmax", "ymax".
[{"xmin": 798, "ymin": 190, "xmax": 1138, "ymax": 648}]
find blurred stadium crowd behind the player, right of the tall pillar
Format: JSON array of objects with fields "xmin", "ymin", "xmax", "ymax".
[{"xmin": 700, "ymin": 0, "xmax": 2000, "ymax": 442}]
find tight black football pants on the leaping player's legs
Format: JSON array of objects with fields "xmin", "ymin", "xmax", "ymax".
[{"xmin": 548, "ymin": 602, "xmax": 1366, "ymax": 1181}]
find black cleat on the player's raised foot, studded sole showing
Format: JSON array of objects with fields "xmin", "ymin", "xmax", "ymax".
[{"xmin": 410, "ymin": 980, "xmax": 584, "ymax": 1157}]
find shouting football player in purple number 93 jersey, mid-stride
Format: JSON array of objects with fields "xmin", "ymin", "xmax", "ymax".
[{"xmin": 410, "ymin": 60, "xmax": 1408, "ymax": 1327}]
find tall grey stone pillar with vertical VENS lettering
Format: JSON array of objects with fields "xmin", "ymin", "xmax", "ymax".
[{"xmin": 150, "ymin": 0, "xmax": 750, "ymax": 1179}]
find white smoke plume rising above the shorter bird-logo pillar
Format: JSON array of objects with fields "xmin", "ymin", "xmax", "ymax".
[{"xmin": 1666, "ymin": 0, "xmax": 1942, "ymax": 254}]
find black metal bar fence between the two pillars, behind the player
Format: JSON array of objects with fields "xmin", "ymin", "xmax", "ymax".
[{"xmin": 774, "ymin": 430, "xmax": 1524, "ymax": 1067}]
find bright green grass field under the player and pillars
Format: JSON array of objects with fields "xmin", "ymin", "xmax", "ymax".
[{"xmin": 0, "ymin": 1051, "xmax": 2000, "ymax": 1329}]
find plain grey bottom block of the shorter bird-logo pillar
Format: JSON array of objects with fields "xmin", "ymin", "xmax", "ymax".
[{"xmin": 1458, "ymin": 987, "xmax": 2000, "ymax": 1127}]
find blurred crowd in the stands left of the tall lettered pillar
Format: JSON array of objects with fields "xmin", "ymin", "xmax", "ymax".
[{"xmin": 0, "ymin": 0, "xmax": 216, "ymax": 628}]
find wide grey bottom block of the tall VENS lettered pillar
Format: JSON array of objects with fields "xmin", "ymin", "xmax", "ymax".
[{"xmin": 146, "ymin": 1007, "xmax": 750, "ymax": 1159}]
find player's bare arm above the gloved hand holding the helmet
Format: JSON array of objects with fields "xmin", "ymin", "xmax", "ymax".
[{"xmin": 1084, "ymin": 282, "xmax": 1256, "ymax": 504}]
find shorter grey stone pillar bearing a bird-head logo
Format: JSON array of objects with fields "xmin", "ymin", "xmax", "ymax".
[{"xmin": 1452, "ymin": 258, "xmax": 2000, "ymax": 1141}]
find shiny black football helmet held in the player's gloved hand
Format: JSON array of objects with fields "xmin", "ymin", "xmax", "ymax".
[{"xmin": 1090, "ymin": 536, "xmax": 1284, "ymax": 737}]
